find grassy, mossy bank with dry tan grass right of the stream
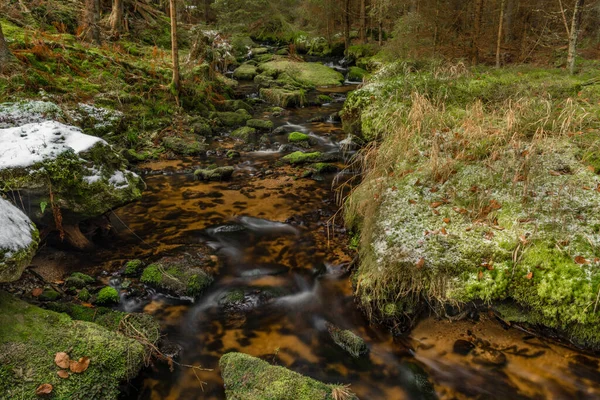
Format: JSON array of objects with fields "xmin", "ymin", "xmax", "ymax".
[{"xmin": 343, "ymin": 64, "xmax": 600, "ymax": 348}]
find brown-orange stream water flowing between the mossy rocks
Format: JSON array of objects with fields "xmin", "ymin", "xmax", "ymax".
[{"xmin": 32, "ymin": 83, "xmax": 600, "ymax": 400}]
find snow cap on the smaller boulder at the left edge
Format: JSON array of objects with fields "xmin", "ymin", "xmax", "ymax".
[{"xmin": 0, "ymin": 198, "xmax": 33, "ymax": 258}]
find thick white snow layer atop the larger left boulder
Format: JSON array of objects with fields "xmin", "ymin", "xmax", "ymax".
[{"xmin": 0, "ymin": 121, "xmax": 107, "ymax": 170}]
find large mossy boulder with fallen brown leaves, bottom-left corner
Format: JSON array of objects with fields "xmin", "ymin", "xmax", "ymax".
[{"xmin": 0, "ymin": 292, "xmax": 146, "ymax": 400}]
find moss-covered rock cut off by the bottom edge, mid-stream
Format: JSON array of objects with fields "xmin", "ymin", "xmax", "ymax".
[{"xmin": 219, "ymin": 353, "xmax": 357, "ymax": 400}]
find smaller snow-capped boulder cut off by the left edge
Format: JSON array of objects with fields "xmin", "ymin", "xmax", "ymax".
[{"xmin": 0, "ymin": 198, "xmax": 39, "ymax": 282}]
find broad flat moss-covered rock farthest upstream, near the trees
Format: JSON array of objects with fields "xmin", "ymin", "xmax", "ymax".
[{"xmin": 258, "ymin": 58, "xmax": 344, "ymax": 88}]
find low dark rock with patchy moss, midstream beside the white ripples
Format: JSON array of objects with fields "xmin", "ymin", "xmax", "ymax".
[{"xmin": 140, "ymin": 255, "xmax": 213, "ymax": 297}]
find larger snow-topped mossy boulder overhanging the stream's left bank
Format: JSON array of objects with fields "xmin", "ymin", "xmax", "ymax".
[{"xmin": 0, "ymin": 121, "xmax": 144, "ymax": 225}]
